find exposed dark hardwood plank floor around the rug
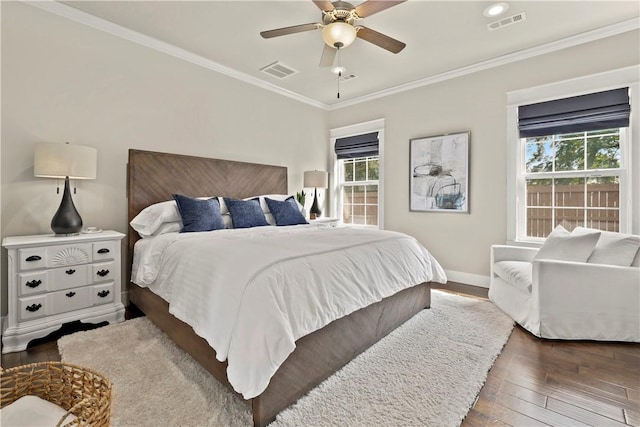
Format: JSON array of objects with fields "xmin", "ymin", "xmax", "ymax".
[{"xmin": 1, "ymin": 283, "xmax": 640, "ymax": 427}]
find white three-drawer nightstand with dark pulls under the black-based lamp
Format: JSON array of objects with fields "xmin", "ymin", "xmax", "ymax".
[{"xmin": 2, "ymin": 231, "xmax": 125, "ymax": 353}]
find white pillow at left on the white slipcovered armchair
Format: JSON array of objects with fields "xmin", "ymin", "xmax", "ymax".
[{"xmin": 534, "ymin": 225, "xmax": 601, "ymax": 262}]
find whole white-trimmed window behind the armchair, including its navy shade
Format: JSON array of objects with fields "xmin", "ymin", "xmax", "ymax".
[{"xmin": 507, "ymin": 66, "xmax": 640, "ymax": 244}]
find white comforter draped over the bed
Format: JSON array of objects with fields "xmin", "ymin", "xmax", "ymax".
[{"xmin": 132, "ymin": 226, "xmax": 446, "ymax": 399}]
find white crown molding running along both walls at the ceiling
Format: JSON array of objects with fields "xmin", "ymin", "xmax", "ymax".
[{"xmin": 22, "ymin": 0, "xmax": 640, "ymax": 111}]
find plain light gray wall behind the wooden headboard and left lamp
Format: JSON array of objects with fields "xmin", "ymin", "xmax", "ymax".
[{"xmin": 0, "ymin": 2, "xmax": 329, "ymax": 314}]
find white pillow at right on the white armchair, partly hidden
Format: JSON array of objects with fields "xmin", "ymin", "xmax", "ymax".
[{"xmin": 571, "ymin": 227, "xmax": 640, "ymax": 267}]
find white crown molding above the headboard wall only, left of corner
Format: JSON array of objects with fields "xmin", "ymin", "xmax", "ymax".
[{"xmin": 23, "ymin": 0, "xmax": 329, "ymax": 110}]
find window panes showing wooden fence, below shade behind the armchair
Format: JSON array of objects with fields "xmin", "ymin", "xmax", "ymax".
[{"xmin": 522, "ymin": 128, "xmax": 625, "ymax": 238}]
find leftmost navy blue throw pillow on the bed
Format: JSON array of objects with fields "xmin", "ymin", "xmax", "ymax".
[{"xmin": 173, "ymin": 194, "xmax": 224, "ymax": 233}]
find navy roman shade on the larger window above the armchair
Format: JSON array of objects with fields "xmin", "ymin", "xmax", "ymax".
[{"xmin": 518, "ymin": 87, "xmax": 631, "ymax": 138}]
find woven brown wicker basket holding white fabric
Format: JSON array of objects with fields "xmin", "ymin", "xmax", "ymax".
[{"xmin": 0, "ymin": 362, "xmax": 111, "ymax": 427}]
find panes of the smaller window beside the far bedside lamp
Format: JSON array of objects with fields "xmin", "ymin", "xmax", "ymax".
[{"xmin": 338, "ymin": 156, "xmax": 380, "ymax": 226}]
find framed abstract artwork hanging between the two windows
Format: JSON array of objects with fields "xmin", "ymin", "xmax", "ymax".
[{"xmin": 409, "ymin": 131, "xmax": 471, "ymax": 213}]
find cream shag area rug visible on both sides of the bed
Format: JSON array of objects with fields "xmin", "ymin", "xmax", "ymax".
[{"xmin": 58, "ymin": 291, "xmax": 513, "ymax": 427}]
